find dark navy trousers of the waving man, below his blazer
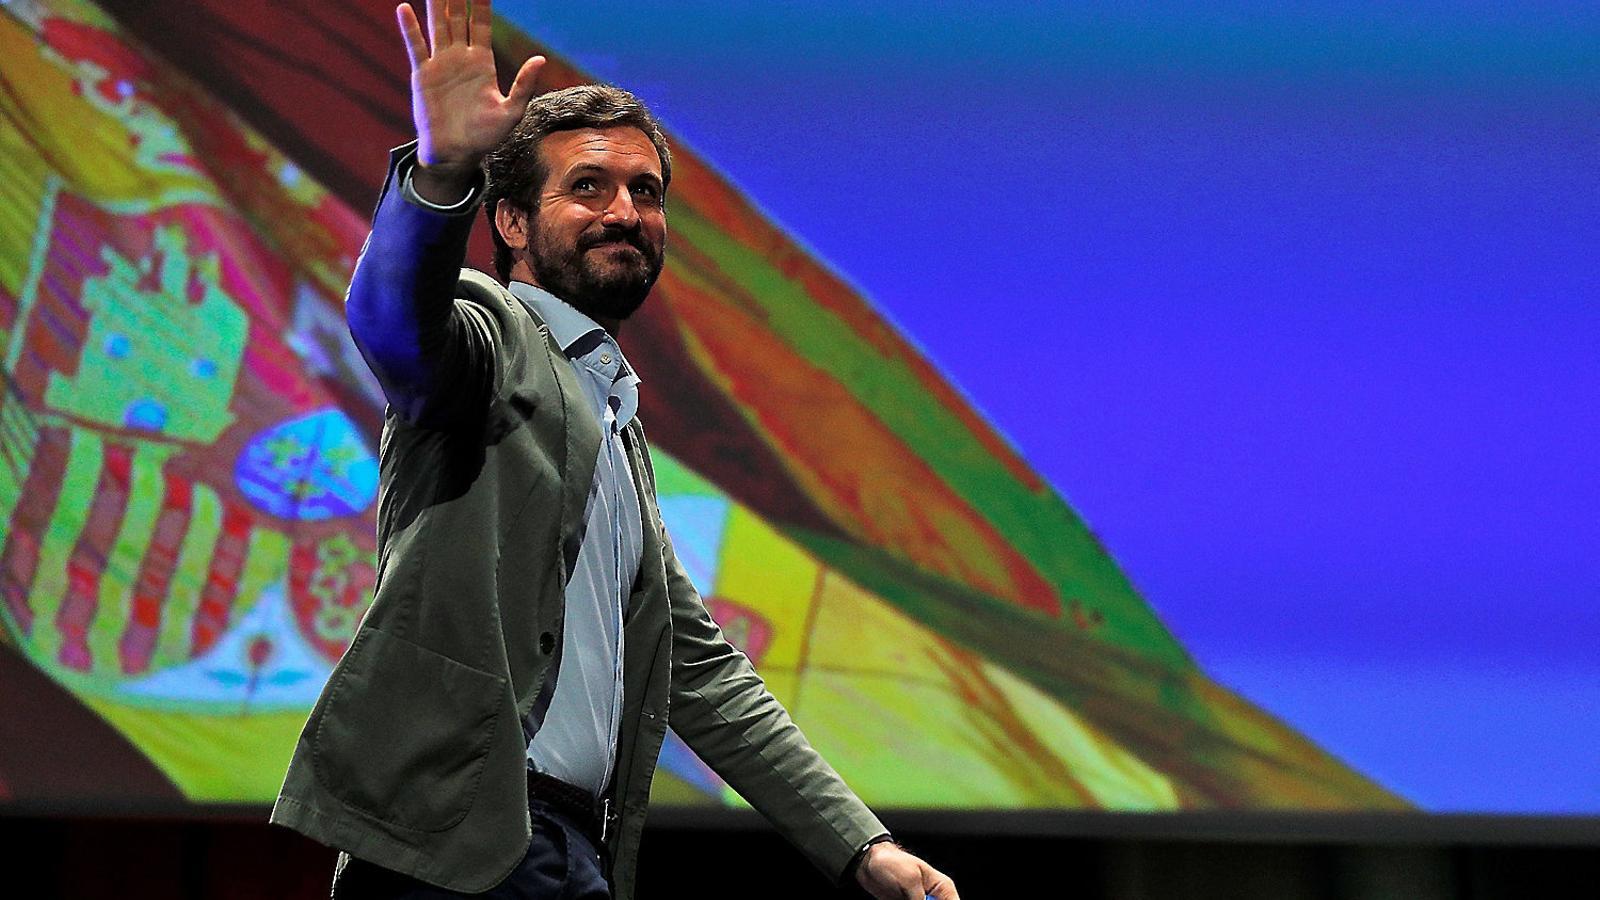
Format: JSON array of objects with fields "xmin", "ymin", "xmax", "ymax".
[{"xmin": 333, "ymin": 801, "xmax": 611, "ymax": 900}]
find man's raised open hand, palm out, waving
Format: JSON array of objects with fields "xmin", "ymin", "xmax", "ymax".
[{"xmin": 395, "ymin": 0, "xmax": 544, "ymax": 195}]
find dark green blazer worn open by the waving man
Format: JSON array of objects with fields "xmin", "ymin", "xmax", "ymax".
[{"xmin": 272, "ymin": 147, "xmax": 885, "ymax": 900}]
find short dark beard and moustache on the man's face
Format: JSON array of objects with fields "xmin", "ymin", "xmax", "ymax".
[{"xmin": 528, "ymin": 219, "xmax": 666, "ymax": 322}]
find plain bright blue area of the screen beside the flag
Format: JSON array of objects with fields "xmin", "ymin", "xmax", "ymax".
[{"xmin": 499, "ymin": 0, "xmax": 1600, "ymax": 814}]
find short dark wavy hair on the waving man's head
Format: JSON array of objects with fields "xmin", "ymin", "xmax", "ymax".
[{"xmin": 483, "ymin": 85, "xmax": 672, "ymax": 282}]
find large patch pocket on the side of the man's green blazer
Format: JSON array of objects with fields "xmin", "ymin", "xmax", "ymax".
[{"xmin": 312, "ymin": 629, "xmax": 507, "ymax": 831}]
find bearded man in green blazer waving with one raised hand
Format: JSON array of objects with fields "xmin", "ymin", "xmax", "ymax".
[{"xmin": 272, "ymin": 0, "xmax": 957, "ymax": 900}]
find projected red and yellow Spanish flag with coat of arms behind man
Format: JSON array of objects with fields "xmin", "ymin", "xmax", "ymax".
[{"xmin": 0, "ymin": 0, "xmax": 1403, "ymax": 810}]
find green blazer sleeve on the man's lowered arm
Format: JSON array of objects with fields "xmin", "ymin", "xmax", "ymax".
[{"xmin": 662, "ymin": 528, "xmax": 888, "ymax": 882}]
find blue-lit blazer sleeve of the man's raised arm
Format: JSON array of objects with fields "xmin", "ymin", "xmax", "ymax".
[{"xmin": 344, "ymin": 141, "xmax": 499, "ymax": 426}]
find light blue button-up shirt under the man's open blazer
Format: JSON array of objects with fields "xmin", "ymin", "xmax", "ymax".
[{"xmin": 510, "ymin": 282, "xmax": 643, "ymax": 796}]
